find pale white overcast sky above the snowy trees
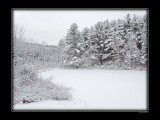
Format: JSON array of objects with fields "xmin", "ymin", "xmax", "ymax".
[{"xmin": 13, "ymin": 10, "xmax": 146, "ymax": 45}]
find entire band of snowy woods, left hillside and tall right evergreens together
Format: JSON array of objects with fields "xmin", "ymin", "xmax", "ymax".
[{"xmin": 13, "ymin": 14, "xmax": 148, "ymax": 69}]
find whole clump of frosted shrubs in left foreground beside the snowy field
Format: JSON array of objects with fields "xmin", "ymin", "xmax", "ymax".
[{"xmin": 13, "ymin": 64, "xmax": 71, "ymax": 104}]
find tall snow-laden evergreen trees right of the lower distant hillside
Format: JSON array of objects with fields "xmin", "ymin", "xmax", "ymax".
[{"xmin": 58, "ymin": 14, "xmax": 148, "ymax": 69}]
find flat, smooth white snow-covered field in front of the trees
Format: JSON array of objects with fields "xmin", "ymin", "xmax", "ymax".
[{"xmin": 14, "ymin": 69, "xmax": 147, "ymax": 110}]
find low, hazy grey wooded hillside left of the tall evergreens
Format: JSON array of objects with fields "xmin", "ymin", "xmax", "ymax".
[{"xmin": 13, "ymin": 41, "xmax": 60, "ymax": 67}]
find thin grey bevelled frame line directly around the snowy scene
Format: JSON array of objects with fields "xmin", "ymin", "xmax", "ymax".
[{"xmin": 11, "ymin": 8, "xmax": 149, "ymax": 113}]
